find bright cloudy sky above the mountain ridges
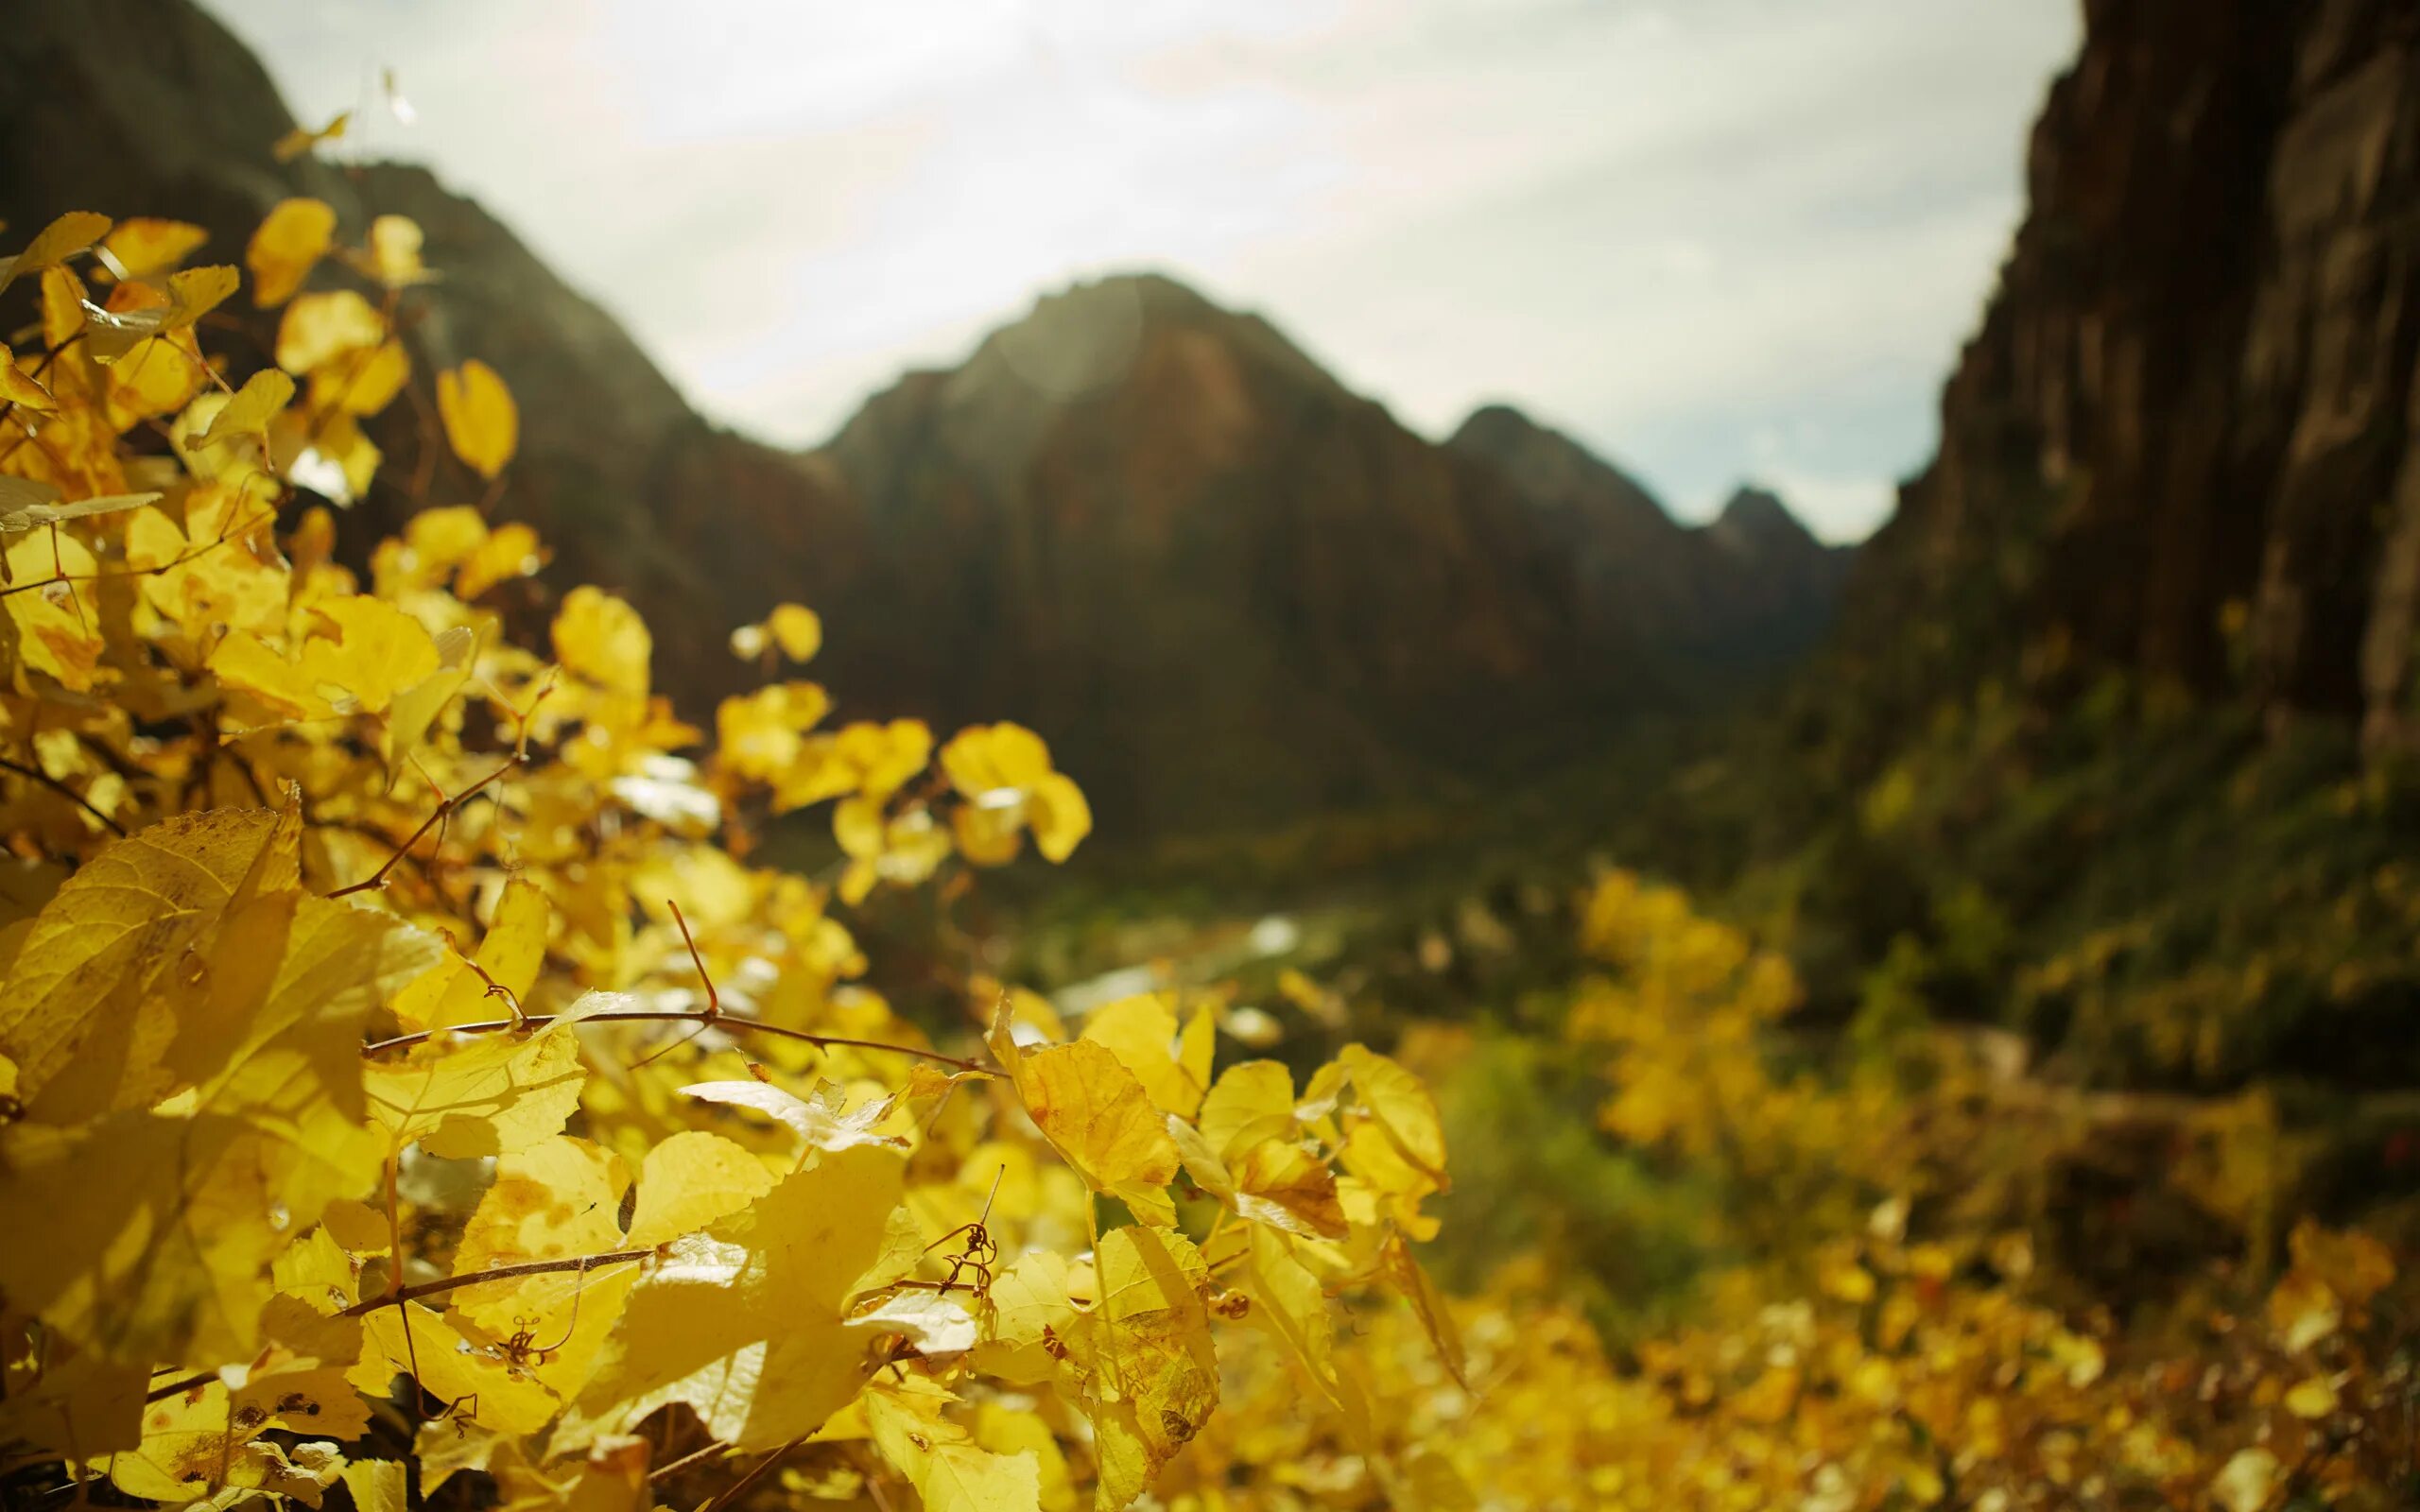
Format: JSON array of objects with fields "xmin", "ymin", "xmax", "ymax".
[{"xmin": 206, "ymin": 0, "xmax": 2079, "ymax": 540}]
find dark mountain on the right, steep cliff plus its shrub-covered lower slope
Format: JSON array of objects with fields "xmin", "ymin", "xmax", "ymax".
[{"xmin": 1612, "ymin": 0, "xmax": 2420, "ymax": 1098}]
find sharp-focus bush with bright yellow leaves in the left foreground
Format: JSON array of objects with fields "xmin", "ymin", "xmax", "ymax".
[{"xmin": 0, "ymin": 200, "xmax": 1466, "ymax": 1512}]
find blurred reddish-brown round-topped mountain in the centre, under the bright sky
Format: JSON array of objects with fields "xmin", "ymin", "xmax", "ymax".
[{"xmin": 825, "ymin": 276, "xmax": 1829, "ymax": 833}]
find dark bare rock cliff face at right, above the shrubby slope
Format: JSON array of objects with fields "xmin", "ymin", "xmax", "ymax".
[{"xmin": 1846, "ymin": 0, "xmax": 2420, "ymax": 743}]
